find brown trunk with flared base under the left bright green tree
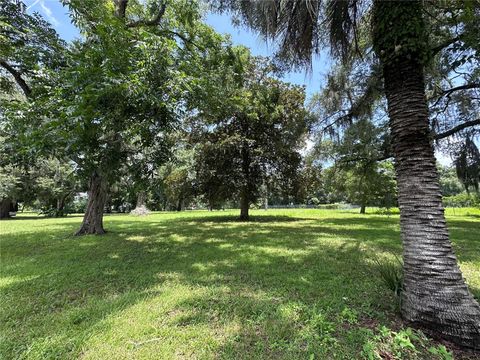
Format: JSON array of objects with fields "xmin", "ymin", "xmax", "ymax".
[{"xmin": 75, "ymin": 172, "xmax": 107, "ymax": 235}]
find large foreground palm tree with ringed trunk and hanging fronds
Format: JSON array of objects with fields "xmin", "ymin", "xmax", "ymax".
[{"xmin": 217, "ymin": 0, "xmax": 480, "ymax": 349}]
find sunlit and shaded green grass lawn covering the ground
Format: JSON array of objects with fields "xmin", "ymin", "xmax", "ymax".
[{"xmin": 0, "ymin": 209, "xmax": 480, "ymax": 360}]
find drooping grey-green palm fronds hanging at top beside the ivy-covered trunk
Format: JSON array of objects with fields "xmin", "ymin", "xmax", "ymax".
[{"xmin": 210, "ymin": 0, "xmax": 365, "ymax": 66}]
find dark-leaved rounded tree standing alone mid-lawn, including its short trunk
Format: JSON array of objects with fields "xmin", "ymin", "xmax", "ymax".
[{"xmin": 194, "ymin": 53, "xmax": 308, "ymax": 220}]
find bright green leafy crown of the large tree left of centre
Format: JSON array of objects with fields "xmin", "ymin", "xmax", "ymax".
[{"xmin": 39, "ymin": 1, "xmax": 206, "ymax": 179}]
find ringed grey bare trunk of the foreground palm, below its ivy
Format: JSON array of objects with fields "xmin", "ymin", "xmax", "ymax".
[{"xmin": 376, "ymin": 1, "xmax": 480, "ymax": 349}]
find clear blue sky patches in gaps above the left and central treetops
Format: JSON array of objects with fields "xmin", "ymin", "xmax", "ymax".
[{"xmin": 25, "ymin": 0, "xmax": 329, "ymax": 96}]
